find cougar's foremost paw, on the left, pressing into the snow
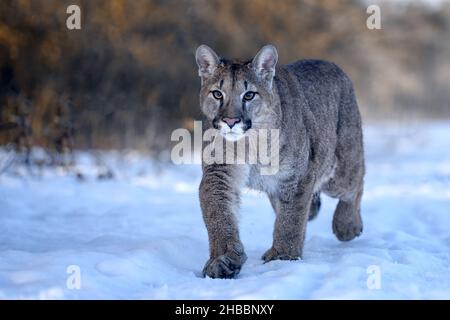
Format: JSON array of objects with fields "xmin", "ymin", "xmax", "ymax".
[{"xmin": 203, "ymin": 253, "xmax": 247, "ymax": 279}]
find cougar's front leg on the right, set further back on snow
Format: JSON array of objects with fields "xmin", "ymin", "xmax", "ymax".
[{"xmin": 262, "ymin": 179, "xmax": 313, "ymax": 262}]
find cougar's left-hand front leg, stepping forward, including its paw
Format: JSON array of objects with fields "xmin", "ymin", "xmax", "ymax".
[{"xmin": 200, "ymin": 164, "xmax": 247, "ymax": 278}]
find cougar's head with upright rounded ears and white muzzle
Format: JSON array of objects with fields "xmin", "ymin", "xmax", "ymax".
[{"xmin": 196, "ymin": 46, "xmax": 276, "ymax": 141}]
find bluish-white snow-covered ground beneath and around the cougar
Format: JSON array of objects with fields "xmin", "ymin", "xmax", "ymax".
[{"xmin": 0, "ymin": 123, "xmax": 450, "ymax": 299}]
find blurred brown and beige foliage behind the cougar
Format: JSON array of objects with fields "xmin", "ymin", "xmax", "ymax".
[{"xmin": 0, "ymin": 0, "xmax": 450, "ymax": 152}]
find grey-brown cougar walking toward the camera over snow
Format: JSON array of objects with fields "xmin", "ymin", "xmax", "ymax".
[{"xmin": 196, "ymin": 45, "xmax": 365, "ymax": 278}]
